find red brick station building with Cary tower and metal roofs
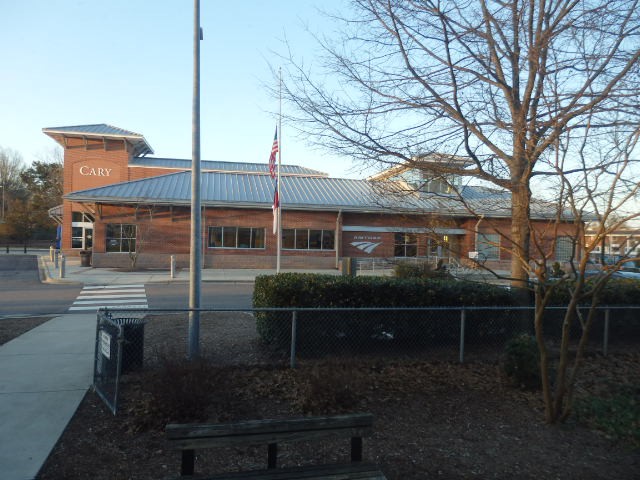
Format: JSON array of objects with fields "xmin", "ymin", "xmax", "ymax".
[{"xmin": 43, "ymin": 124, "xmax": 575, "ymax": 268}]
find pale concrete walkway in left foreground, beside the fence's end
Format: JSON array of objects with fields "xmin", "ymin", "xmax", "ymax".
[{"xmin": 0, "ymin": 313, "xmax": 96, "ymax": 480}]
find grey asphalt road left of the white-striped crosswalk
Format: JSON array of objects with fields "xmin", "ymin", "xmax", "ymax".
[{"xmin": 0, "ymin": 255, "xmax": 81, "ymax": 318}]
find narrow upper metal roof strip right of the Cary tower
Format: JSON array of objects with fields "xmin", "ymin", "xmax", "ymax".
[{"xmin": 129, "ymin": 157, "xmax": 329, "ymax": 177}]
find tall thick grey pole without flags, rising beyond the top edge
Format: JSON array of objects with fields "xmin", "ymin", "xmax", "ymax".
[{"xmin": 188, "ymin": 0, "xmax": 202, "ymax": 360}]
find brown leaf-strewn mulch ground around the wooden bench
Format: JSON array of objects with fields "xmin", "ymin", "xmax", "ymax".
[{"xmin": 3, "ymin": 316, "xmax": 640, "ymax": 480}]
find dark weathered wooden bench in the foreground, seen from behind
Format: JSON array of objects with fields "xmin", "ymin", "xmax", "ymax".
[{"xmin": 165, "ymin": 413, "xmax": 386, "ymax": 480}]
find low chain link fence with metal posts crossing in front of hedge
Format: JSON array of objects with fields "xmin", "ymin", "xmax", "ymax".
[{"xmin": 94, "ymin": 306, "xmax": 640, "ymax": 413}]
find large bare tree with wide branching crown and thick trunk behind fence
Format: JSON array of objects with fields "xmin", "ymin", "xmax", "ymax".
[{"xmin": 284, "ymin": 0, "xmax": 640, "ymax": 287}]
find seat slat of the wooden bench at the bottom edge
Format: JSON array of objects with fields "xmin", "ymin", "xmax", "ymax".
[{"xmin": 200, "ymin": 463, "xmax": 387, "ymax": 480}]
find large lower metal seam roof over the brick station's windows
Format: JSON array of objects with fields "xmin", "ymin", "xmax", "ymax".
[{"xmin": 64, "ymin": 167, "xmax": 532, "ymax": 216}]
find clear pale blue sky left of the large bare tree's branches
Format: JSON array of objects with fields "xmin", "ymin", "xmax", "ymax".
[{"xmin": 0, "ymin": 0, "xmax": 363, "ymax": 178}]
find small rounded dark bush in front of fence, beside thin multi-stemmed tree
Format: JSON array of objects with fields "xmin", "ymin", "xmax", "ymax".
[{"xmin": 503, "ymin": 334, "xmax": 541, "ymax": 390}]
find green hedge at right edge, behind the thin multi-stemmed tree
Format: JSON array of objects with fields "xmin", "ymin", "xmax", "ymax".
[{"xmin": 544, "ymin": 278, "xmax": 640, "ymax": 342}]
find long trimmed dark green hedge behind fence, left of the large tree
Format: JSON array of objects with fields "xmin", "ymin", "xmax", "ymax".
[{"xmin": 253, "ymin": 273, "xmax": 515, "ymax": 354}]
